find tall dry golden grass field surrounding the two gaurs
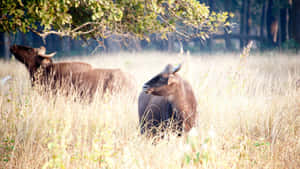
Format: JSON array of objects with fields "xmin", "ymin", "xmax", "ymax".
[{"xmin": 0, "ymin": 52, "xmax": 300, "ymax": 169}]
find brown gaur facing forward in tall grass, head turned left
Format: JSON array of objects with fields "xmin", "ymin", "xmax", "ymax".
[{"xmin": 138, "ymin": 64, "xmax": 197, "ymax": 135}]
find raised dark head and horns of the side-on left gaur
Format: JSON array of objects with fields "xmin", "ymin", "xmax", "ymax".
[{"xmin": 10, "ymin": 45, "xmax": 56, "ymax": 71}]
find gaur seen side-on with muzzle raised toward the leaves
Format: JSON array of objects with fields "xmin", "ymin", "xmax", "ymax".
[{"xmin": 10, "ymin": 45, "xmax": 135, "ymax": 100}]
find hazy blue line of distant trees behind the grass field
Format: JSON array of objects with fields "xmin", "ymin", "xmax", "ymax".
[{"xmin": 0, "ymin": 0, "xmax": 300, "ymax": 58}]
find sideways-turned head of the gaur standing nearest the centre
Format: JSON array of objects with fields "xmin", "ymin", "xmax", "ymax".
[{"xmin": 143, "ymin": 64, "xmax": 182, "ymax": 96}]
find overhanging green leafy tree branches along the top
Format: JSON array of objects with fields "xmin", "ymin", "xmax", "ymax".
[{"xmin": 0, "ymin": 0, "xmax": 230, "ymax": 41}]
